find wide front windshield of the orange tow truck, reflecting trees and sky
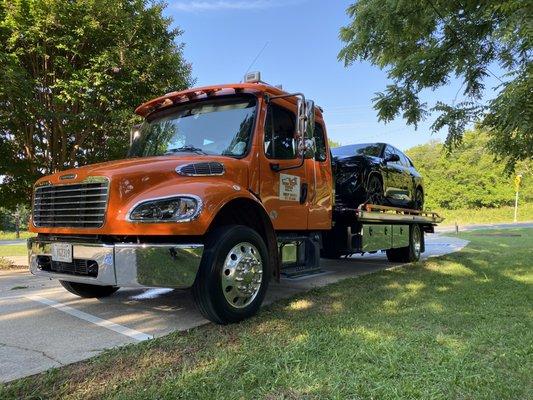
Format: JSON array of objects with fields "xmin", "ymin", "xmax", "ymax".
[{"xmin": 129, "ymin": 96, "xmax": 256, "ymax": 157}]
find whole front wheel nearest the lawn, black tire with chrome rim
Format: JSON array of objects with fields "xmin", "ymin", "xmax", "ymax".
[{"xmin": 193, "ymin": 225, "xmax": 270, "ymax": 324}]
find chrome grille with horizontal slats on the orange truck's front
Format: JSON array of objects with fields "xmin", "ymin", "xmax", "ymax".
[{"xmin": 33, "ymin": 180, "xmax": 109, "ymax": 228}]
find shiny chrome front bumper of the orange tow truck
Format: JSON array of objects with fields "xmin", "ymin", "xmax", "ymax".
[{"xmin": 28, "ymin": 238, "xmax": 204, "ymax": 288}]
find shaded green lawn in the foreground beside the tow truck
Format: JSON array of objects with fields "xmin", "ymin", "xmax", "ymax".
[{"xmin": 0, "ymin": 229, "xmax": 533, "ymax": 400}]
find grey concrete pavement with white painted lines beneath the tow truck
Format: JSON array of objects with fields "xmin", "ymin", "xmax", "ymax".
[{"xmin": 0, "ymin": 235, "xmax": 467, "ymax": 382}]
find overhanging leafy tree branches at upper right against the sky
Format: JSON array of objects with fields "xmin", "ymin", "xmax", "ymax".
[{"xmin": 339, "ymin": 0, "xmax": 533, "ymax": 171}]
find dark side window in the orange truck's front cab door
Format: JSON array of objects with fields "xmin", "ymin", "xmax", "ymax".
[{"xmin": 265, "ymin": 103, "xmax": 297, "ymax": 160}]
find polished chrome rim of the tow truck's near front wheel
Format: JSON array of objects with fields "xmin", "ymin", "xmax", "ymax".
[{"xmin": 222, "ymin": 242, "xmax": 263, "ymax": 308}]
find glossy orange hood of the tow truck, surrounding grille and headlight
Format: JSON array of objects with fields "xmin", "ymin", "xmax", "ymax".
[{"xmin": 31, "ymin": 154, "xmax": 256, "ymax": 236}]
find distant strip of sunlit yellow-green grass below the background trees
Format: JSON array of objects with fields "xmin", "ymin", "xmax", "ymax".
[{"xmin": 432, "ymin": 203, "xmax": 533, "ymax": 225}]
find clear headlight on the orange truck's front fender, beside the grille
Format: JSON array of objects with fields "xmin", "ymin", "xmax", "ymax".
[{"xmin": 128, "ymin": 196, "xmax": 201, "ymax": 222}]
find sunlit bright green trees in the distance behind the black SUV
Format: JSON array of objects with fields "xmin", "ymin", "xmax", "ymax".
[{"xmin": 406, "ymin": 131, "xmax": 533, "ymax": 209}]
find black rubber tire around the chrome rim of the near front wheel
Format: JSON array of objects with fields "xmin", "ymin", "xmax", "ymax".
[{"xmin": 192, "ymin": 225, "xmax": 270, "ymax": 324}]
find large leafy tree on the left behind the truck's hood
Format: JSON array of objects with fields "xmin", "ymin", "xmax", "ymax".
[{"xmin": 0, "ymin": 0, "xmax": 192, "ymax": 207}]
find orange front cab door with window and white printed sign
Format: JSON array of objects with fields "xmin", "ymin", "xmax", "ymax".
[{"xmin": 259, "ymin": 101, "xmax": 309, "ymax": 230}]
